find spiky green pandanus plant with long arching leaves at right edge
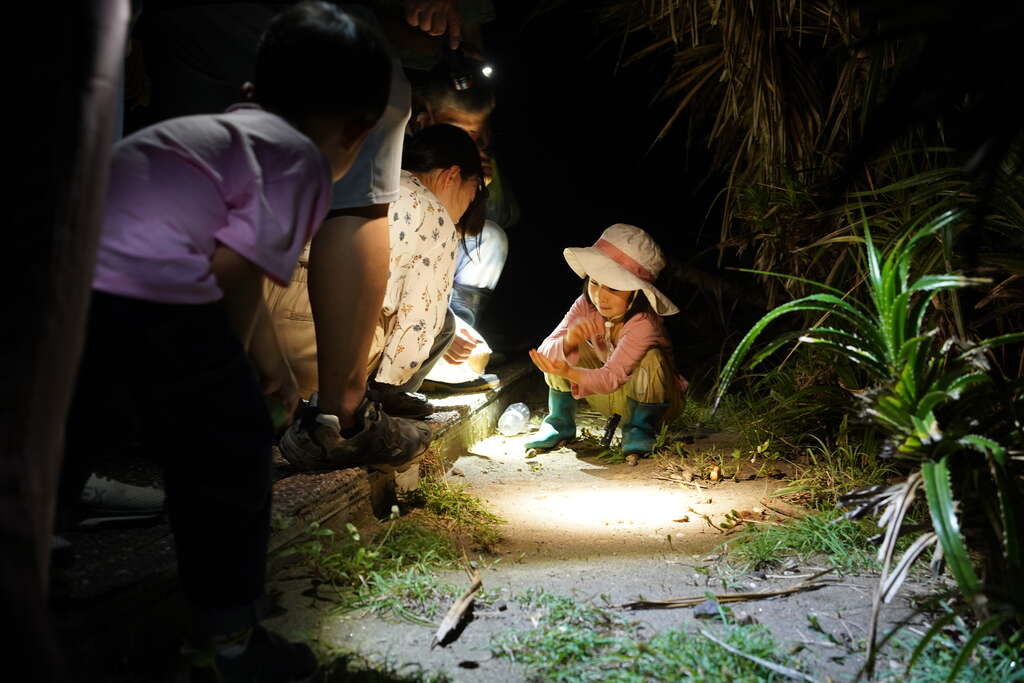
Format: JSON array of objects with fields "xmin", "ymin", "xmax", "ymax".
[{"xmin": 715, "ymin": 211, "xmax": 1024, "ymax": 680}]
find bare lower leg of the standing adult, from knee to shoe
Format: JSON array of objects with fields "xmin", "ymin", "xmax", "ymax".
[{"xmin": 309, "ymin": 204, "xmax": 390, "ymax": 428}]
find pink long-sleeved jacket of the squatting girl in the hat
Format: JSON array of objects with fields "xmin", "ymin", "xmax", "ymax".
[{"xmin": 538, "ymin": 296, "xmax": 682, "ymax": 398}]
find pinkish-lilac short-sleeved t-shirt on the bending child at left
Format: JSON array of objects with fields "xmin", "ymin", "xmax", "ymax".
[{"xmin": 92, "ymin": 104, "xmax": 331, "ymax": 304}]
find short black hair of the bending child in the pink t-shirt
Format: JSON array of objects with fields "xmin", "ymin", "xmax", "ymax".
[{"xmin": 254, "ymin": 0, "xmax": 391, "ymax": 128}]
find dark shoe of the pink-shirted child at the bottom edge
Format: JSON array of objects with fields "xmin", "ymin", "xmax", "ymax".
[{"xmin": 183, "ymin": 626, "xmax": 318, "ymax": 683}]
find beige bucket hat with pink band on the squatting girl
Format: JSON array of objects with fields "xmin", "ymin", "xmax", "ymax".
[{"xmin": 562, "ymin": 223, "xmax": 679, "ymax": 315}]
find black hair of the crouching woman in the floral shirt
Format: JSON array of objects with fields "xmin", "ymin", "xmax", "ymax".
[{"xmin": 401, "ymin": 123, "xmax": 487, "ymax": 237}]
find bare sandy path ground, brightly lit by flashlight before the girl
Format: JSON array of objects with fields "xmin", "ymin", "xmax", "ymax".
[{"xmin": 270, "ymin": 423, "xmax": 937, "ymax": 681}]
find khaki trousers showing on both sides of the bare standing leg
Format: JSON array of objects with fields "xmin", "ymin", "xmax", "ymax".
[{"xmin": 263, "ymin": 263, "xmax": 394, "ymax": 396}]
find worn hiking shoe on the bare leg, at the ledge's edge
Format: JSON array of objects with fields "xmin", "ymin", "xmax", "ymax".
[{"xmin": 280, "ymin": 394, "xmax": 432, "ymax": 472}]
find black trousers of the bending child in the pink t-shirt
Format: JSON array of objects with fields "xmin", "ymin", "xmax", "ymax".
[{"xmin": 61, "ymin": 292, "xmax": 272, "ymax": 637}]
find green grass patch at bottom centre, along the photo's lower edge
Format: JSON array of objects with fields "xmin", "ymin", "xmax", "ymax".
[{"xmin": 492, "ymin": 591, "xmax": 794, "ymax": 683}]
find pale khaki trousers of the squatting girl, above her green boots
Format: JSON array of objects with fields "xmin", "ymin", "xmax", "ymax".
[{"xmin": 544, "ymin": 344, "xmax": 682, "ymax": 422}]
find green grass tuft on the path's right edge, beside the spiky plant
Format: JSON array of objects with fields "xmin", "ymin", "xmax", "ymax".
[{"xmin": 729, "ymin": 511, "xmax": 878, "ymax": 571}]
